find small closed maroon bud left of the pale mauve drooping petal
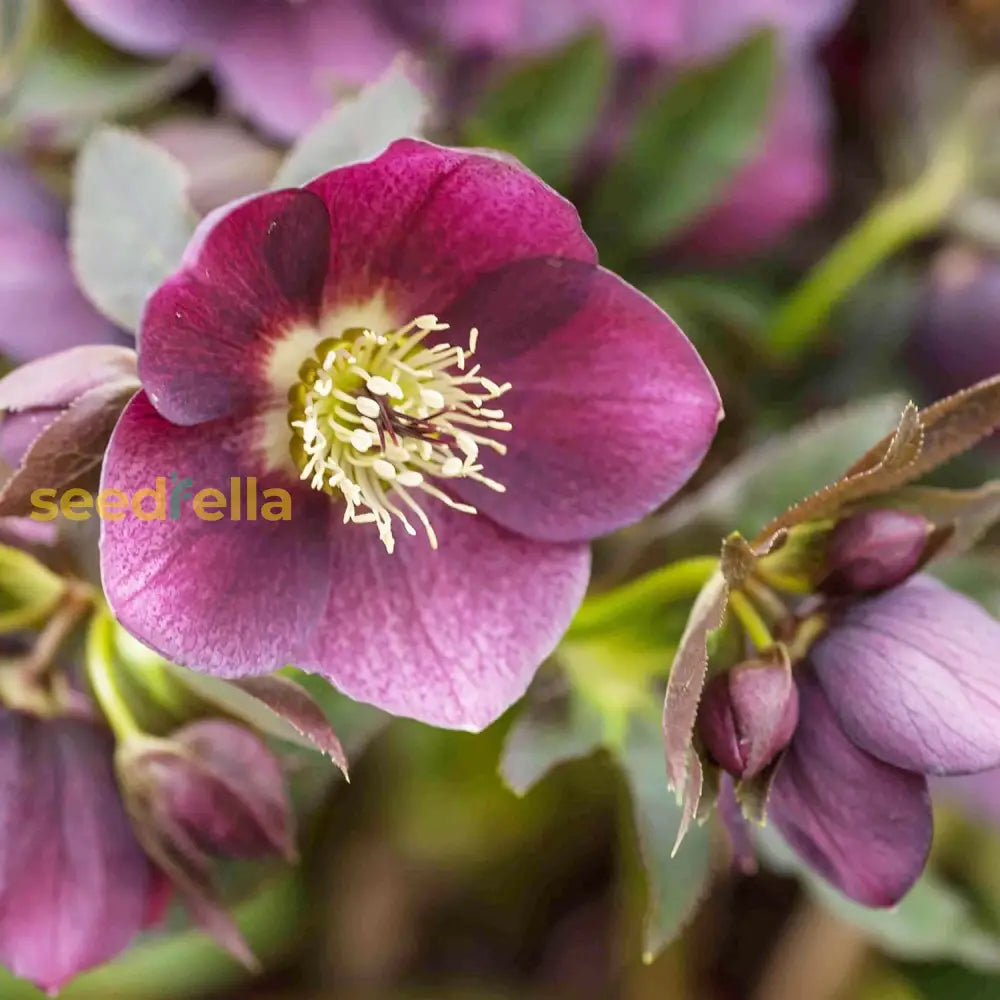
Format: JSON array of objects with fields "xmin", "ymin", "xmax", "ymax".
[{"xmin": 698, "ymin": 659, "xmax": 799, "ymax": 779}]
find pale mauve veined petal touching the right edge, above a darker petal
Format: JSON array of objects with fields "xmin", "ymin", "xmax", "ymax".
[{"xmin": 810, "ymin": 576, "xmax": 1000, "ymax": 774}]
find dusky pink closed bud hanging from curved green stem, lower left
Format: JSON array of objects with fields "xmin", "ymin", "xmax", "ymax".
[{"xmin": 119, "ymin": 719, "xmax": 294, "ymax": 867}]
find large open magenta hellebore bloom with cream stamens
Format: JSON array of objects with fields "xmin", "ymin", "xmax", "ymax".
[{"xmin": 102, "ymin": 140, "xmax": 720, "ymax": 729}]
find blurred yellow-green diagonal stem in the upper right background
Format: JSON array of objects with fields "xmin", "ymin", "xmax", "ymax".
[{"xmin": 764, "ymin": 117, "xmax": 972, "ymax": 360}]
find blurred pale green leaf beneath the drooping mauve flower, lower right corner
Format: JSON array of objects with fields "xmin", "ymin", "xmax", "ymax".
[{"xmin": 757, "ymin": 828, "xmax": 1000, "ymax": 970}]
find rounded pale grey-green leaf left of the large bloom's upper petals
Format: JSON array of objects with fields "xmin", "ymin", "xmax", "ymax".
[{"xmin": 70, "ymin": 126, "xmax": 196, "ymax": 331}]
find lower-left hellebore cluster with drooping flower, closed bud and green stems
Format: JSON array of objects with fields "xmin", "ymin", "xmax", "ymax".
[{"xmin": 0, "ymin": 508, "xmax": 346, "ymax": 992}]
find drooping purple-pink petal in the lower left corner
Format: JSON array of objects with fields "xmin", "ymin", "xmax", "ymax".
[{"xmin": 0, "ymin": 712, "xmax": 150, "ymax": 992}]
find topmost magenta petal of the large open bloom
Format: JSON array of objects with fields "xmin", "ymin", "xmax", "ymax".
[{"xmin": 308, "ymin": 139, "xmax": 597, "ymax": 323}]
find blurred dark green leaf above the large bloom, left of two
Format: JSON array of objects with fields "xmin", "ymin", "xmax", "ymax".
[{"xmin": 465, "ymin": 33, "xmax": 612, "ymax": 187}]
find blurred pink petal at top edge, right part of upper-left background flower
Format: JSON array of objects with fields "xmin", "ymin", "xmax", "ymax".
[{"xmin": 215, "ymin": 0, "xmax": 402, "ymax": 139}]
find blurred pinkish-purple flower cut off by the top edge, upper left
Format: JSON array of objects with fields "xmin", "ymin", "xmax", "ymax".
[{"xmin": 68, "ymin": 0, "xmax": 402, "ymax": 139}]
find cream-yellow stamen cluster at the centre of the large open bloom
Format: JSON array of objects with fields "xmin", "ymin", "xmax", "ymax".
[{"xmin": 288, "ymin": 316, "xmax": 511, "ymax": 552}]
